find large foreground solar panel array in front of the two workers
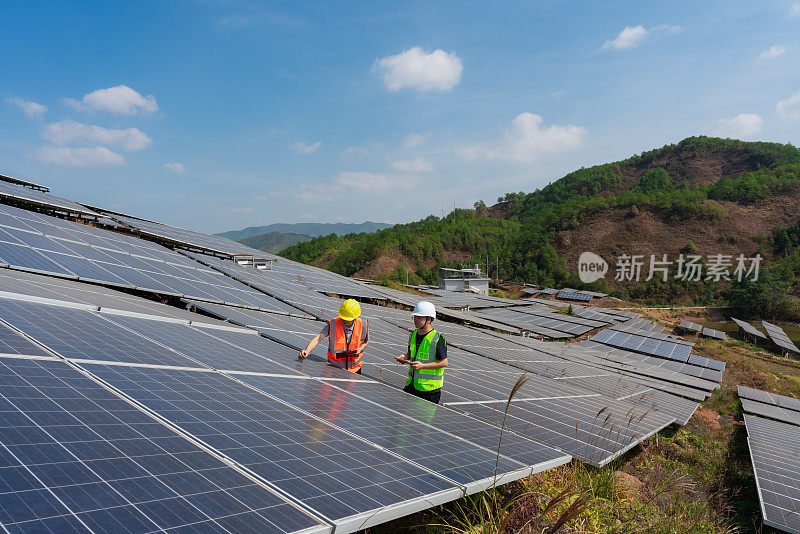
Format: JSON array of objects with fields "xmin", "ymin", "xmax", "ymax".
[{"xmin": 0, "ymin": 295, "xmax": 569, "ymax": 532}]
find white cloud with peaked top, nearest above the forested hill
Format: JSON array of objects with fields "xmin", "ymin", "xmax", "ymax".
[{"xmin": 457, "ymin": 112, "xmax": 588, "ymax": 162}]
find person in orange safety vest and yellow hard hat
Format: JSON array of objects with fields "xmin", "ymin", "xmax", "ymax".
[{"xmin": 300, "ymin": 299, "xmax": 369, "ymax": 374}]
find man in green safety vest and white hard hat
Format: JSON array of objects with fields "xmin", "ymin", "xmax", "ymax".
[{"xmin": 395, "ymin": 300, "xmax": 447, "ymax": 404}]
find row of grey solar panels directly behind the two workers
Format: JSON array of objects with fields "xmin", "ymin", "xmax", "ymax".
[{"xmin": 183, "ymin": 302, "xmax": 696, "ymax": 465}]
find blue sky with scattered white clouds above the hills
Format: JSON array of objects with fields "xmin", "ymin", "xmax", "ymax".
[{"xmin": 0, "ymin": 0, "xmax": 800, "ymax": 232}]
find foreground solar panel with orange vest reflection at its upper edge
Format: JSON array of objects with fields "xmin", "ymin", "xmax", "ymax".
[{"xmin": 79, "ymin": 364, "xmax": 463, "ymax": 531}]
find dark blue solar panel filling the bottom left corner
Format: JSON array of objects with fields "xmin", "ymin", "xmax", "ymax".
[{"xmin": 0, "ymin": 358, "xmax": 329, "ymax": 533}]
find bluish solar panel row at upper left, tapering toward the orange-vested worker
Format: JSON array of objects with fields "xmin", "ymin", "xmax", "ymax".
[{"xmin": 0, "ymin": 205, "xmax": 302, "ymax": 309}]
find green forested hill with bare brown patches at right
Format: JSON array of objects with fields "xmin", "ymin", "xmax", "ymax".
[{"xmin": 282, "ymin": 137, "xmax": 800, "ymax": 320}]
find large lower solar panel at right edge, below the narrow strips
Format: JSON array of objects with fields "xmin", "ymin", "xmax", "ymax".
[{"xmin": 744, "ymin": 415, "xmax": 800, "ymax": 533}]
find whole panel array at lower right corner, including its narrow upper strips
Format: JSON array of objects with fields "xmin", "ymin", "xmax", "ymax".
[{"xmin": 739, "ymin": 386, "xmax": 800, "ymax": 534}]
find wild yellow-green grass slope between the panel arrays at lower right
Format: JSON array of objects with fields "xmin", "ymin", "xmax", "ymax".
[{"xmin": 370, "ymin": 339, "xmax": 800, "ymax": 534}]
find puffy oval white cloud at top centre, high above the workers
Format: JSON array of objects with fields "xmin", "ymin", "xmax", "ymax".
[{"xmin": 372, "ymin": 46, "xmax": 463, "ymax": 92}]
